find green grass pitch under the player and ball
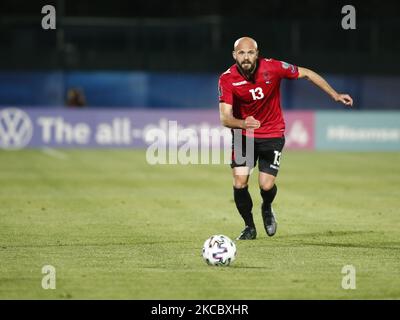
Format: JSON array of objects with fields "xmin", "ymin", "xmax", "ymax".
[{"xmin": 0, "ymin": 150, "xmax": 400, "ymax": 299}]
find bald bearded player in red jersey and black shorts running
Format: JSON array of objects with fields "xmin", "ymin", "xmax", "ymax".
[{"xmin": 218, "ymin": 37, "xmax": 353, "ymax": 240}]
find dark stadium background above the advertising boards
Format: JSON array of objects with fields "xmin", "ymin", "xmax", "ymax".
[{"xmin": 0, "ymin": 0, "xmax": 400, "ymax": 110}]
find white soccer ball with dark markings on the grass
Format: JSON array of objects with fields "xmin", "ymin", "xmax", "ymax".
[{"xmin": 203, "ymin": 234, "xmax": 236, "ymax": 266}]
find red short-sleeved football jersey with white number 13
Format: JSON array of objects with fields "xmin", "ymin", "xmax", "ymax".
[{"xmin": 218, "ymin": 58, "xmax": 299, "ymax": 138}]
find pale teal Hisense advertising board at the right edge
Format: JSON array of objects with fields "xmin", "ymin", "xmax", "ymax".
[{"xmin": 315, "ymin": 111, "xmax": 400, "ymax": 151}]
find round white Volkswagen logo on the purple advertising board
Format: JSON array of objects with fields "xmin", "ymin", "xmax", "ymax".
[{"xmin": 0, "ymin": 108, "xmax": 33, "ymax": 150}]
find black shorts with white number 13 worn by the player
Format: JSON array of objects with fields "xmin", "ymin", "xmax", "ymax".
[{"xmin": 231, "ymin": 134, "xmax": 285, "ymax": 177}]
